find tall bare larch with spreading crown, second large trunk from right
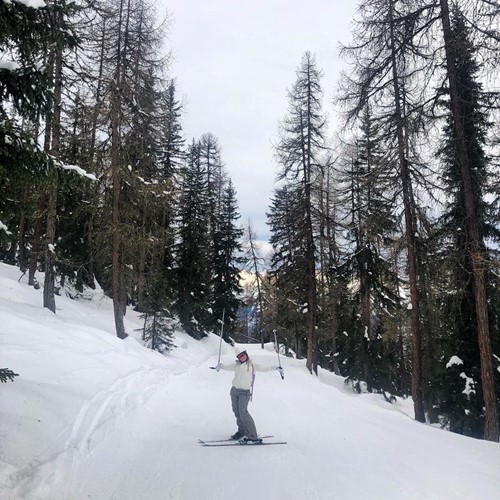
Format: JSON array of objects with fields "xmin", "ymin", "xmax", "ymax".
[{"xmin": 342, "ymin": 0, "xmax": 431, "ymax": 422}]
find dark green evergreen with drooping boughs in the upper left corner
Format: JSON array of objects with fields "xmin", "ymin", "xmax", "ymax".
[{"xmin": 0, "ymin": 0, "xmax": 76, "ymax": 269}]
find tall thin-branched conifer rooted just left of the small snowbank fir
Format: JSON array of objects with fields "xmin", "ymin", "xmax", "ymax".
[{"xmin": 99, "ymin": 0, "xmax": 170, "ymax": 338}]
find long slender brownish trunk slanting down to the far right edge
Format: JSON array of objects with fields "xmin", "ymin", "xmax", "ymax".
[{"xmin": 440, "ymin": 0, "xmax": 500, "ymax": 441}]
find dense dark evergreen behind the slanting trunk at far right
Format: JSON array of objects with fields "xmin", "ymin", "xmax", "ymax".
[{"xmin": 439, "ymin": 8, "xmax": 500, "ymax": 437}]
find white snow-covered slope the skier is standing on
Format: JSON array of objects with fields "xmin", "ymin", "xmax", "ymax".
[{"xmin": 0, "ymin": 264, "xmax": 500, "ymax": 500}]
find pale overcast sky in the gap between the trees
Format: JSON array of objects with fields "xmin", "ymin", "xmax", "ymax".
[{"xmin": 159, "ymin": 0, "xmax": 357, "ymax": 240}]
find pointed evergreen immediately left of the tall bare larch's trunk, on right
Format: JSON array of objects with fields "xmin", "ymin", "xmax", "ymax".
[{"xmin": 343, "ymin": 108, "xmax": 399, "ymax": 392}]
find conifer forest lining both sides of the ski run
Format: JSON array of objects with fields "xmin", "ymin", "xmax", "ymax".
[{"xmin": 0, "ymin": 0, "xmax": 500, "ymax": 441}]
